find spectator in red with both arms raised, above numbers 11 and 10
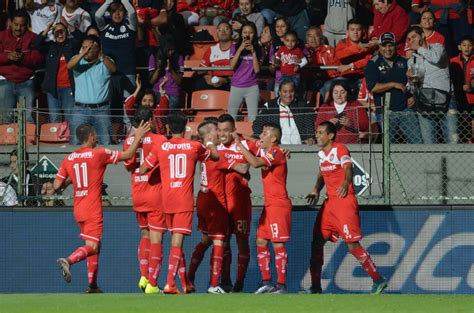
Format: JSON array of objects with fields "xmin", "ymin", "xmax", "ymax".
[{"xmin": 125, "ymin": 74, "xmax": 169, "ymax": 134}]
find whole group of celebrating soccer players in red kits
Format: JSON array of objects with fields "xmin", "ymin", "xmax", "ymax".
[{"xmin": 53, "ymin": 106, "xmax": 387, "ymax": 294}]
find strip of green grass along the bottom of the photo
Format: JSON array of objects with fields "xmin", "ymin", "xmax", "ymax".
[{"xmin": 0, "ymin": 294, "xmax": 474, "ymax": 313}]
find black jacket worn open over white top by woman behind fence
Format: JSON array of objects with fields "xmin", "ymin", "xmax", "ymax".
[{"xmin": 252, "ymin": 98, "xmax": 316, "ymax": 141}]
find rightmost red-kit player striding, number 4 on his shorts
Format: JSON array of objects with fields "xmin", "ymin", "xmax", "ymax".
[{"xmin": 306, "ymin": 122, "xmax": 387, "ymax": 294}]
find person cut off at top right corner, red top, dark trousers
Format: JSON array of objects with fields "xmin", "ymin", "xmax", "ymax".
[{"xmin": 430, "ymin": 0, "xmax": 472, "ymax": 56}]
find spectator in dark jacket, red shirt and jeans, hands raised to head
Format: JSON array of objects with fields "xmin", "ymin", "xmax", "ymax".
[{"xmin": 35, "ymin": 21, "xmax": 82, "ymax": 123}]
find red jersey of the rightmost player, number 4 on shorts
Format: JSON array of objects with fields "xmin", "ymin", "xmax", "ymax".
[{"xmin": 318, "ymin": 143, "xmax": 354, "ymax": 198}]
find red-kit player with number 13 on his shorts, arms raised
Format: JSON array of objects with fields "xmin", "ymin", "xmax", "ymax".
[{"xmin": 233, "ymin": 123, "xmax": 292, "ymax": 294}]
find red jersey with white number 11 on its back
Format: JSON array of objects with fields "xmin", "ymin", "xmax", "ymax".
[{"xmin": 56, "ymin": 148, "xmax": 121, "ymax": 222}]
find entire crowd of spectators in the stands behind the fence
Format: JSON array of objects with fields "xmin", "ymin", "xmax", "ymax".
[{"xmin": 0, "ymin": 0, "xmax": 474, "ymax": 144}]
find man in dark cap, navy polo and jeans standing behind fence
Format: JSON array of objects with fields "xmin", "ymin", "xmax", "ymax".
[{"xmin": 364, "ymin": 32, "xmax": 422, "ymax": 144}]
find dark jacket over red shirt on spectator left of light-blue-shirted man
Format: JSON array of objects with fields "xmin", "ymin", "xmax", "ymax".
[{"xmin": 34, "ymin": 29, "xmax": 84, "ymax": 97}]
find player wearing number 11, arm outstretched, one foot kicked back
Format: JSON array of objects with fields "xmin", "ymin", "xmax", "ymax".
[{"xmin": 53, "ymin": 123, "xmax": 150, "ymax": 293}]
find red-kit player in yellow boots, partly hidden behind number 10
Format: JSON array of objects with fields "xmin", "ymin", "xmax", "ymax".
[{"xmin": 123, "ymin": 106, "xmax": 167, "ymax": 294}]
